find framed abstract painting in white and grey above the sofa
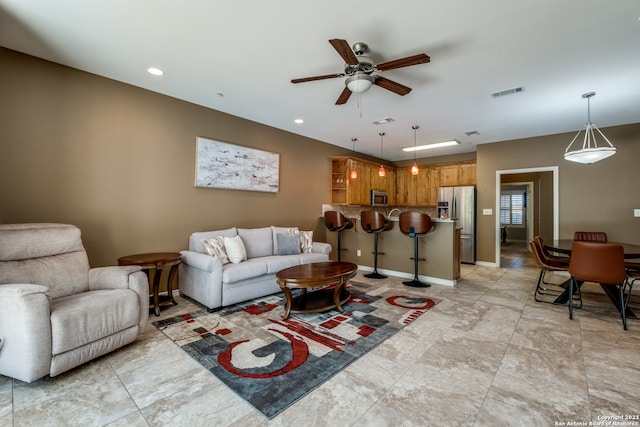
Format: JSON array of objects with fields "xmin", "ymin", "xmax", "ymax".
[{"xmin": 195, "ymin": 137, "xmax": 280, "ymax": 193}]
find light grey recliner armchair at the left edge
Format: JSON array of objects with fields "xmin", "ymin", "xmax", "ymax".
[{"xmin": 0, "ymin": 224, "xmax": 149, "ymax": 382}]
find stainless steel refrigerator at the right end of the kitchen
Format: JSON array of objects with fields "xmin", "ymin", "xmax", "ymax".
[{"xmin": 437, "ymin": 186, "xmax": 476, "ymax": 264}]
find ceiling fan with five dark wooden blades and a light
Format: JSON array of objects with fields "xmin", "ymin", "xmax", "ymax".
[{"xmin": 291, "ymin": 39, "xmax": 431, "ymax": 105}]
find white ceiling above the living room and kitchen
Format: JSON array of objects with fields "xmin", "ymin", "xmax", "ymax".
[{"xmin": 0, "ymin": 0, "xmax": 640, "ymax": 161}]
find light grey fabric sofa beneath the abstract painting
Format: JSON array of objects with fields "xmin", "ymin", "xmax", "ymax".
[{"xmin": 179, "ymin": 226, "xmax": 331, "ymax": 310}]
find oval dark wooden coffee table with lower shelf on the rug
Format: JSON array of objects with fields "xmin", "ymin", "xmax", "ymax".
[{"xmin": 276, "ymin": 261, "xmax": 358, "ymax": 320}]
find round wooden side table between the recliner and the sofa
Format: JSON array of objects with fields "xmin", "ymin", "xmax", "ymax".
[{"xmin": 118, "ymin": 252, "xmax": 180, "ymax": 316}]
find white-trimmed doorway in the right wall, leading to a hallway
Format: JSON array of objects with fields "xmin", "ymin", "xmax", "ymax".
[{"xmin": 495, "ymin": 166, "xmax": 559, "ymax": 267}]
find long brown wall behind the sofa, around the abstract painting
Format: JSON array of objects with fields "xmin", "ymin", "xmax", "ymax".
[{"xmin": 0, "ymin": 48, "xmax": 350, "ymax": 266}]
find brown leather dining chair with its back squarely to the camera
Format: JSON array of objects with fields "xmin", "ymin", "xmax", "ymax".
[{"xmin": 569, "ymin": 241, "xmax": 632, "ymax": 330}]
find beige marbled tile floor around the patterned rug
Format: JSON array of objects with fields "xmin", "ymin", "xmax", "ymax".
[{"xmin": 0, "ymin": 245, "xmax": 640, "ymax": 427}]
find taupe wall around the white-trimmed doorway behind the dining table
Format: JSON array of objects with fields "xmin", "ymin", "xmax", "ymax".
[{"xmin": 477, "ymin": 123, "xmax": 640, "ymax": 263}]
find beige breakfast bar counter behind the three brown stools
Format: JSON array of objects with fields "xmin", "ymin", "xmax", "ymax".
[{"xmin": 326, "ymin": 216, "xmax": 460, "ymax": 286}]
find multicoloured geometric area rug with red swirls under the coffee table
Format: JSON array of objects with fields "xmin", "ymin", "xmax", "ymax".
[{"xmin": 154, "ymin": 281, "xmax": 436, "ymax": 419}]
